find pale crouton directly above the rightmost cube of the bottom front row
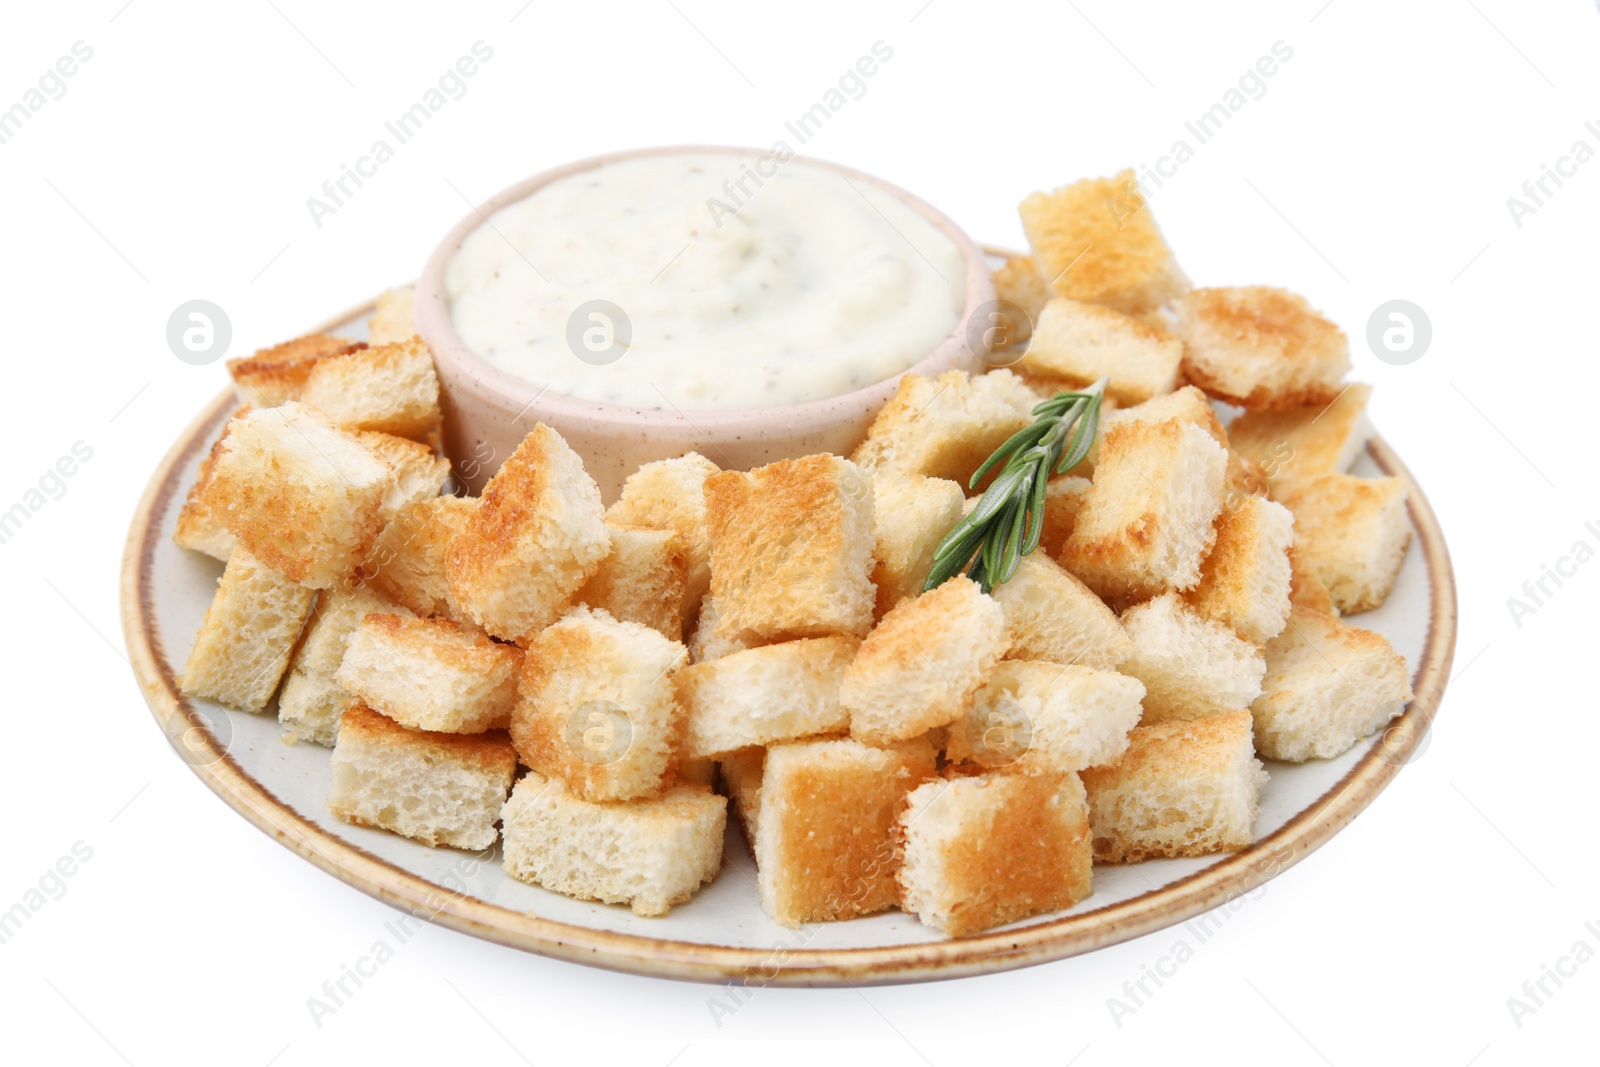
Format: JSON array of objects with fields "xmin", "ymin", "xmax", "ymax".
[{"xmin": 1120, "ymin": 593, "xmax": 1267, "ymax": 725}]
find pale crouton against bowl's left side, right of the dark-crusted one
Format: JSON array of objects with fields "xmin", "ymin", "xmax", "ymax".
[{"xmin": 301, "ymin": 338, "xmax": 440, "ymax": 440}]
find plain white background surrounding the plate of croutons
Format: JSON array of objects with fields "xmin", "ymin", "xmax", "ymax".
[{"xmin": 0, "ymin": 0, "xmax": 1600, "ymax": 1067}]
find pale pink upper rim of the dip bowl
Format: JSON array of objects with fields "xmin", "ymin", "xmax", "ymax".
[{"xmin": 413, "ymin": 144, "xmax": 997, "ymax": 437}]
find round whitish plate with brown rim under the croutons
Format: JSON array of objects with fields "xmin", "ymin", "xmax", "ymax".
[{"xmin": 122, "ymin": 253, "xmax": 1456, "ymax": 985}]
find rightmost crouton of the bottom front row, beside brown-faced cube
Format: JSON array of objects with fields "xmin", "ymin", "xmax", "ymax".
[{"xmin": 1083, "ymin": 710, "xmax": 1267, "ymax": 864}]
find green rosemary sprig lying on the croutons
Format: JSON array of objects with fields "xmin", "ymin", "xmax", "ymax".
[{"xmin": 923, "ymin": 378, "xmax": 1107, "ymax": 593}]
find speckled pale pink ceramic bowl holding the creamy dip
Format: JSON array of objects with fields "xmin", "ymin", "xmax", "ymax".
[{"xmin": 416, "ymin": 147, "xmax": 995, "ymax": 502}]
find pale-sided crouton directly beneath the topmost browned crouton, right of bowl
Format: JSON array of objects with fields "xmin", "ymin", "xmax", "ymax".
[{"xmin": 1018, "ymin": 298, "xmax": 1184, "ymax": 405}]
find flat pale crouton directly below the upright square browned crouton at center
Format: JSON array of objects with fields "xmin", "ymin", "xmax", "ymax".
[{"xmin": 675, "ymin": 637, "xmax": 861, "ymax": 758}]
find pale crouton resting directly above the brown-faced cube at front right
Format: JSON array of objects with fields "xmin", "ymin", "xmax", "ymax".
[{"xmin": 944, "ymin": 659, "xmax": 1144, "ymax": 774}]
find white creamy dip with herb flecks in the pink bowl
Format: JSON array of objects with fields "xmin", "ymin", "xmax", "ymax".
[{"xmin": 445, "ymin": 152, "xmax": 965, "ymax": 411}]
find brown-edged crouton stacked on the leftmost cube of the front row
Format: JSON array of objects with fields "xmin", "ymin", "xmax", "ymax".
[{"xmin": 336, "ymin": 613, "xmax": 522, "ymax": 734}]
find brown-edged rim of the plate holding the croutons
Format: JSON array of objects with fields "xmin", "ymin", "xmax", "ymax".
[{"xmin": 120, "ymin": 281, "xmax": 1458, "ymax": 987}]
